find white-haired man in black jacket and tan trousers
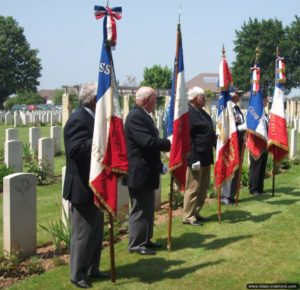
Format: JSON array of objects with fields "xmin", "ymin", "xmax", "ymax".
[{"xmin": 182, "ymin": 87, "xmax": 216, "ymax": 226}]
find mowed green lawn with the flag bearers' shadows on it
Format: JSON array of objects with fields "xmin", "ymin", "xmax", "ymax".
[{"xmin": 0, "ymin": 123, "xmax": 300, "ymax": 290}]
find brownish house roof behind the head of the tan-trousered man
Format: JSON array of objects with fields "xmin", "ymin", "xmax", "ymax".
[{"xmin": 186, "ymin": 73, "xmax": 220, "ymax": 93}]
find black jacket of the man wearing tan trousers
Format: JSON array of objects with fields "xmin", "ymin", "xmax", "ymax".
[{"xmin": 188, "ymin": 104, "xmax": 216, "ymax": 166}]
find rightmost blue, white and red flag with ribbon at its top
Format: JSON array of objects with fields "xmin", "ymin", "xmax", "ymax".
[{"xmin": 268, "ymin": 57, "xmax": 289, "ymax": 162}]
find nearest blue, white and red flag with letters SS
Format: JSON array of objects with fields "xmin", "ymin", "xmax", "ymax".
[{"xmin": 90, "ymin": 41, "xmax": 128, "ymax": 215}]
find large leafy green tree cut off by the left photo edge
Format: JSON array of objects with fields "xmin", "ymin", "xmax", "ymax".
[{"xmin": 0, "ymin": 16, "xmax": 42, "ymax": 108}]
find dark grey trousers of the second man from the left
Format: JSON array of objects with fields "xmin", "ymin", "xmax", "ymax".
[{"xmin": 128, "ymin": 188, "xmax": 155, "ymax": 250}]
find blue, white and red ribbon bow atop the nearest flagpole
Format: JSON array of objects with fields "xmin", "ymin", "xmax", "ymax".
[{"xmin": 95, "ymin": 6, "xmax": 122, "ymax": 47}]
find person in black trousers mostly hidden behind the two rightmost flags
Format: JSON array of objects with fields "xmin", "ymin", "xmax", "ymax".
[{"xmin": 249, "ymin": 97, "xmax": 269, "ymax": 196}]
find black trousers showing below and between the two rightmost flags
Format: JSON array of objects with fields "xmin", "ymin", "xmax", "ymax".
[{"xmin": 249, "ymin": 151, "xmax": 268, "ymax": 193}]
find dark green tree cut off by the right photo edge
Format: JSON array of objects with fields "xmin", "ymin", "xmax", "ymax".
[{"xmin": 279, "ymin": 16, "xmax": 300, "ymax": 89}]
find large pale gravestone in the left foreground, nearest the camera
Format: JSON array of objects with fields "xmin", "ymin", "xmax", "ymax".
[{"xmin": 3, "ymin": 173, "xmax": 36, "ymax": 257}]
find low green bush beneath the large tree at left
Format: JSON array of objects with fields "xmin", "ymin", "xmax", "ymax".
[{"xmin": 5, "ymin": 91, "xmax": 45, "ymax": 109}]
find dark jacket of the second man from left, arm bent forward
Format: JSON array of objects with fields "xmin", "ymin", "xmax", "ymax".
[{"xmin": 125, "ymin": 106, "xmax": 171, "ymax": 190}]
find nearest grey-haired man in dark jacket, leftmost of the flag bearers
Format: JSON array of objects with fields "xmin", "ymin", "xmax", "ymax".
[{"xmin": 63, "ymin": 83, "xmax": 107, "ymax": 288}]
